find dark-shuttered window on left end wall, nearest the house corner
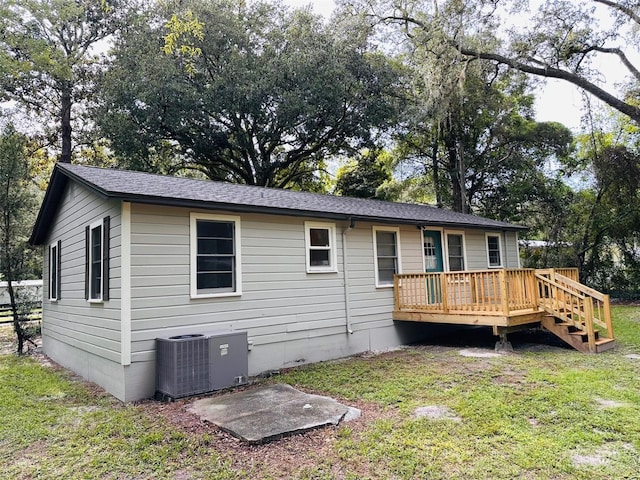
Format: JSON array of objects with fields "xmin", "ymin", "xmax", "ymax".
[{"xmin": 85, "ymin": 217, "xmax": 110, "ymax": 303}]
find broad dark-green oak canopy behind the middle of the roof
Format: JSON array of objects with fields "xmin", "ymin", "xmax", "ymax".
[{"xmin": 99, "ymin": 0, "xmax": 401, "ymax": 187}]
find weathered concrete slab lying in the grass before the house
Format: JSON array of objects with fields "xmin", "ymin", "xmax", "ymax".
[{"xmin": 189, "ymin": 384, "xmax": 359, "ymax": 443}]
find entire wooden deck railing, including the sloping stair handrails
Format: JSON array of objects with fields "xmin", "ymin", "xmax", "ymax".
[{"xmin": 394, "ymin": 268, "xmax": 613, "ymax": 351}]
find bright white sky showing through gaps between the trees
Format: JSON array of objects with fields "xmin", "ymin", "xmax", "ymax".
[{"xmin": 284, "ymin": 0, "xmax": 640, "ymax": 132}]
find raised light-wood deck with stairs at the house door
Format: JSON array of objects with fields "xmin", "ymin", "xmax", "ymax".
[{"xmin": 393, "ymin": 269, "xmax": 613, "ymax": 353}]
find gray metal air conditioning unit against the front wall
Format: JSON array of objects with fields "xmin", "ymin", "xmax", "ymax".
[{"xmin": 156, "ymin": 332, "xmax": 249, "ymax": 400}]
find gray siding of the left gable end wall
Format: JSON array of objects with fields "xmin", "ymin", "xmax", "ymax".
[{"xmin": 42, "ymin": 182, "xmax": 121, "ymax": 364}]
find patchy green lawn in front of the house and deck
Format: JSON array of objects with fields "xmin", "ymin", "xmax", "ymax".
[{"xmin": 0, "ymin": 307, "xmax": 640, "ymax": 479}]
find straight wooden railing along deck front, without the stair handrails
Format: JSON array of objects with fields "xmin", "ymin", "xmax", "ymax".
[{"xmin": 395, "ymin": 269, "xmax": 538, "ymax": 315}]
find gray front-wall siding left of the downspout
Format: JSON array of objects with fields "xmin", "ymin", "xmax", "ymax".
[{"xmin": 131, "ymin": 204, "xmax": 346, "ymax": 373}]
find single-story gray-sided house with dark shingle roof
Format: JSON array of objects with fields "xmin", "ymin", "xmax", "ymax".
[{"xmin": 30, "ymin": 164, "xmax": 523, "ymax": 401}]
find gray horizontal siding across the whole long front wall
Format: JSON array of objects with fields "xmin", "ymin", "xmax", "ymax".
[{"xmin": 126, "ymin": 208, "xmax": 524, "ymax": 373}]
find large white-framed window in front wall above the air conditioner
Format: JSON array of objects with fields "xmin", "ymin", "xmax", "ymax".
[{"xmin": 191, "ymin": 213, "xmax": 241, "ymax": 297}]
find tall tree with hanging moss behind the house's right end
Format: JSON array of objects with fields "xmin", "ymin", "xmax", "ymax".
[{"xmin": 390, "ymin": 39, "xmax": 572, "ymax": 216}]
